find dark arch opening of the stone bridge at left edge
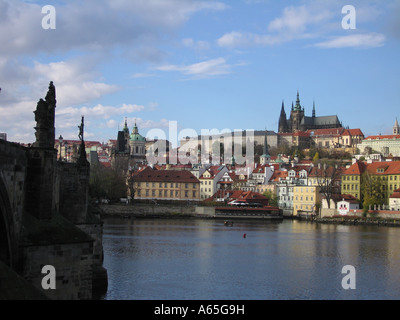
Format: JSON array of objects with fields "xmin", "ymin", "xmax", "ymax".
[{"xmin": 0, "ymin": 175, "xmax": 16, "ymax": 267}]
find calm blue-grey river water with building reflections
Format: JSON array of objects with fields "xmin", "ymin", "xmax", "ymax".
[{"xmin": 103, "ymin": 218, "xmax": 400, "ymax": 300}]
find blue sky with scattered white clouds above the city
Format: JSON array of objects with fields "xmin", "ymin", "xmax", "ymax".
[{"xmin": 0, "ymin": 0, "xmax": 400, "ymax": 143}]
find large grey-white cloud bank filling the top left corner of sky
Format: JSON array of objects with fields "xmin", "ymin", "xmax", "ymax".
[{"xmin": 0, "ymin": 0, "xmax": 228, "ymax": 59}]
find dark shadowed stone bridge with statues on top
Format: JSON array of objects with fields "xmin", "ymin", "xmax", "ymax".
[{"xmin": 0, "ymin": 83, "xmax": 107, "ymax": 300}]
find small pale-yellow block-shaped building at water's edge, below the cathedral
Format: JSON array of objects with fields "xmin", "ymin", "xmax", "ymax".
[{"xmin": 293, "ymin": 186, "xmax": 320, "ymax": 216}]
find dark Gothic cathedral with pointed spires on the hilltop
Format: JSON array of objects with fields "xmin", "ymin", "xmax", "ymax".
[{"xmin": 278, "ymin": 92, "xmax": 342, "ymax": 133}]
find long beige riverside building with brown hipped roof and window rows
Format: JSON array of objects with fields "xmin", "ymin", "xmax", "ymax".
[{"xmin": 133, "ymin": 167, "xmax": 200, "ymax": 201}]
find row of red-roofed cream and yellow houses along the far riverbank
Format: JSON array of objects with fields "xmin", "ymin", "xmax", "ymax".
[{"xmin": 126, "ymin": 157, "xmax": 400, "ymax": 216}]
